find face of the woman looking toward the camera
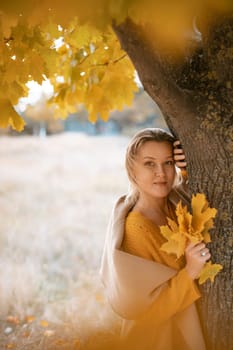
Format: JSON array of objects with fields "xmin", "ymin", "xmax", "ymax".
[{"xmin": 133, "ymin": 141, "xmax": 176, "ymax": 198}]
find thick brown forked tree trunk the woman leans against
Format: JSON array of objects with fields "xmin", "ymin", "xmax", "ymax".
[{"xmin": 114, "ymin": 13, "xmax": 233, "ymax": 350}]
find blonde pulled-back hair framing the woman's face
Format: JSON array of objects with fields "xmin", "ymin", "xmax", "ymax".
[{"xmin": 125, "ymin": 128, "xmax": 182, "ymax": 203}]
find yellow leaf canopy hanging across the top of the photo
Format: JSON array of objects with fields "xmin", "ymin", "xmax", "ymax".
[{"xmin": 0, "ymin": 0, "xmax": 233, "ymax": 130}]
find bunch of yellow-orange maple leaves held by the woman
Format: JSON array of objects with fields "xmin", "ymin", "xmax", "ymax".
[{"xmin": 160, "ymin": 193, "xmax": 222, "ymax": 284}]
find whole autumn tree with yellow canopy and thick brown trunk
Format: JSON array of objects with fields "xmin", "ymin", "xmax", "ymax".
[{"xmin": 0, "ymin": 0, "xmax": 233, "ymax": 350}]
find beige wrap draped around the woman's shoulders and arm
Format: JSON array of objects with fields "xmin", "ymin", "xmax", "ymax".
[{"xmin": 100, "ymin": 189, "xmax": 206, "ymax": 350}]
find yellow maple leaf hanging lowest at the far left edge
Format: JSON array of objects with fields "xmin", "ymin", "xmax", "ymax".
[{"xmin": 0, "ymin": 99, "xmax": 25, "ymax": 131}]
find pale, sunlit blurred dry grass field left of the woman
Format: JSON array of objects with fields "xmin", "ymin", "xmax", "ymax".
[{"xmin": 0, "ymin": 133, "xmax": 128, "ymax": 350}]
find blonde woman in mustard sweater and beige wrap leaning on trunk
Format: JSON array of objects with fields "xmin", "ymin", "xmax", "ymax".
[{"xmin": 101, "ymin": 129, "xmax": 210, "ymax": 350}]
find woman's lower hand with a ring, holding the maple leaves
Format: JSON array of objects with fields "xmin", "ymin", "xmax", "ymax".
[{"xmin": 185, "ymin": 242, "xmax": 211, "ymax": 280}]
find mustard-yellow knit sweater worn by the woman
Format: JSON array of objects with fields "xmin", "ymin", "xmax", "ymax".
[{"xmin": 122, "ymin": 206, "xmax": 200, "ymax": 350}]
